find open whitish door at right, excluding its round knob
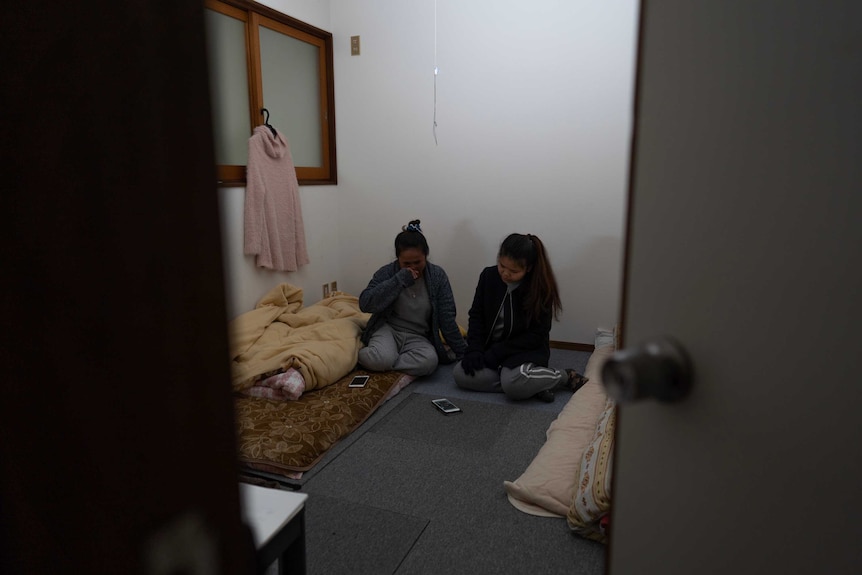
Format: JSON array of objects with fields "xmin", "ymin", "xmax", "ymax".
[{"xmin": 608, "ymin": 0, "xmax": 862, "ymax": 575}]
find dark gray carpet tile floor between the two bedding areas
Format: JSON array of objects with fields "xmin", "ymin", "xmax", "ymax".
[{"xmin": 270, "ymin": 350, "xmax": 605, "ymax": 575}]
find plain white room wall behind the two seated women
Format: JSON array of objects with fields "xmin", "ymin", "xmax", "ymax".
[{"xmin": 222, "ymin": 0, "xmax": 637, "ymax": 344}]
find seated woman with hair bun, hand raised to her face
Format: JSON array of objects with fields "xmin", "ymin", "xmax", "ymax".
[{"xmin": 359, "ymin": 220, "xmax": 467, "ymax": 377}]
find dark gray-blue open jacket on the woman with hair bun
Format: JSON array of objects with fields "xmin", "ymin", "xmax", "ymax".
[{"xmin": 359, "ymin": 260, "xmax": 467, "ymax": 363}]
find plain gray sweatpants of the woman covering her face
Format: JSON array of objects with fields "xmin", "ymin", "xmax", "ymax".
[{"xmin": 359, "ymin": 324, "xmax": 439, "ymax": 377}]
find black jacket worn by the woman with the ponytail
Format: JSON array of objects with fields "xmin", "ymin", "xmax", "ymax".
[{"xmin": 467, "ymin": 266, "xmax": 553, "ymax": 368}]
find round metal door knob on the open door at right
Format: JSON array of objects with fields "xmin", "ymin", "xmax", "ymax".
[{"xmin": 602, "ymin": 337, "xmax": 692, "ymax": 403}]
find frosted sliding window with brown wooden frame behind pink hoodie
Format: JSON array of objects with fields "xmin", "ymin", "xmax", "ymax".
[{"xmin": 204, "ymin": 0, "xmax": 337, "ymax": 186}]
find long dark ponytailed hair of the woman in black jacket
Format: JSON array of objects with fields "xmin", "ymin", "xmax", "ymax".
[{"xmin": 497, "ymin": 234, "xmax": 563, "ymax": 322}]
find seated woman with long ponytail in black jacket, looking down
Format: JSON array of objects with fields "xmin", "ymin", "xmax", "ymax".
[{"xmin": 453, "ymin": 234, "xmax": 587, "ymax": 402}]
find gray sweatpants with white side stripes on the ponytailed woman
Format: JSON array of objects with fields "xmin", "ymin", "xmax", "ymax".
[{"xmin": 452, "ymin": 361, "xmax": 568, "ymax": 399}]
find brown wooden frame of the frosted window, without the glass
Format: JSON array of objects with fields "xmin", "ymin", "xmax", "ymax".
[{"xmin": 204, "ymin": 0, "xmax": 338, "ymax": 187}]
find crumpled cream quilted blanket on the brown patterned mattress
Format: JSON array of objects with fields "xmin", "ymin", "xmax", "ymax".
[{"xmin": 228, "ymin": 283, "xmax": 371, "ymax": 392}]
